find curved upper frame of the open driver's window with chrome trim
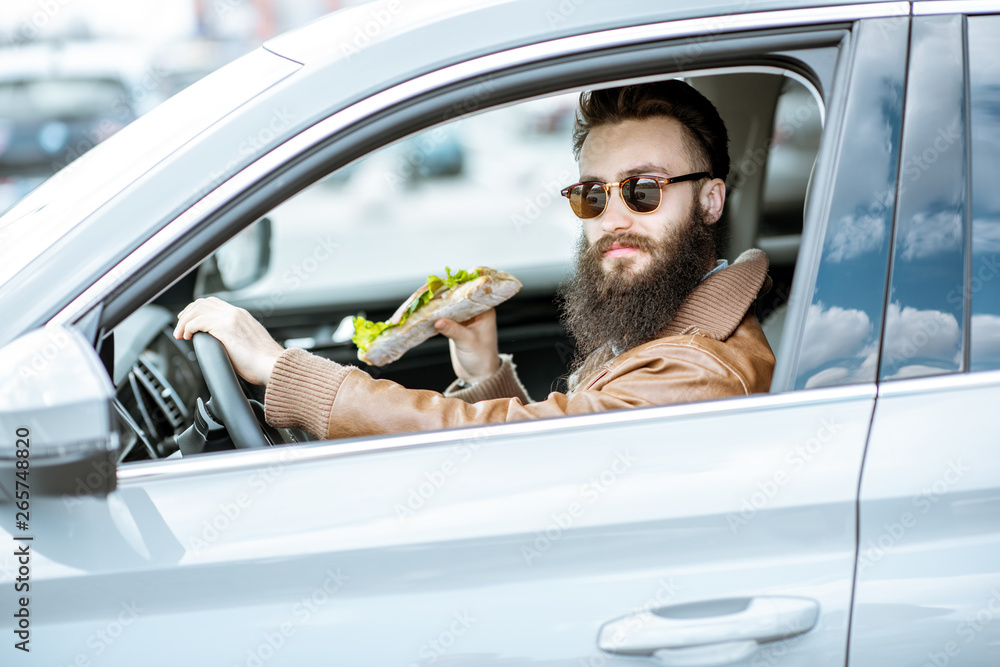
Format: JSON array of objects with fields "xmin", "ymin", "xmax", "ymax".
[{"xmin": 84, "ymin": 30, "xmax": 848, "ymax": 354}]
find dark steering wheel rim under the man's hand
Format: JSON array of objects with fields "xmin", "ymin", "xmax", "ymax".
[{"xmin": 191, "ymin": 331, "xmax": 268, "ymax": 449}]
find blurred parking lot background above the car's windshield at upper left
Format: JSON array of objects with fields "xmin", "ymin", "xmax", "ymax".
[{"xmin": 0, "ymin": 0, "xmax": 374, "ymax": 213}]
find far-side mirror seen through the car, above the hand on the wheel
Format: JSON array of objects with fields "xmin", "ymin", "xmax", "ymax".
[{"xmin": 195, "ymin": 218, "xmax": 271, "ymax": 296}]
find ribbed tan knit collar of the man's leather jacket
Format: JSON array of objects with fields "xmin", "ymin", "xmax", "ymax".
[{"xmin": 663, "ymin": 248, "xmax": 771, "ymax": 340}]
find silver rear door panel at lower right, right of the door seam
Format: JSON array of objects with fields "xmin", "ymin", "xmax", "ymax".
[{"xmin": 850, "ymin": 372, "xmax": 1000, "ymax": 667}]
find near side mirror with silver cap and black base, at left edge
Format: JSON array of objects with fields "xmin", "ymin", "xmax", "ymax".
[{"xmin": 0, "ymin": 327, "xmax": 118, "ymax": 498}]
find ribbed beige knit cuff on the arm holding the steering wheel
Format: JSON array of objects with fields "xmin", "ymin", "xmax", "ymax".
[{"xmin": 264, "ymin": 348, "xmax": 357, "ymax": 439}]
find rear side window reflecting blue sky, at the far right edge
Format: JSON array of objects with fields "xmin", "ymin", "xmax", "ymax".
[{"xmin": 968, "ymin": 16, "xmax": 1000, "ymax": 370}]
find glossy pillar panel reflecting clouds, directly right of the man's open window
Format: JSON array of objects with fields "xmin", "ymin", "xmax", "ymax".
[{"xmin": 791, "ymin": 20, "xmax": 906, "ymax": 389}]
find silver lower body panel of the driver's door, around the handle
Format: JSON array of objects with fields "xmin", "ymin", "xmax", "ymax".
[{"xmin": 19, "ymin": 387, "xmax": 873, "ymax": 666}]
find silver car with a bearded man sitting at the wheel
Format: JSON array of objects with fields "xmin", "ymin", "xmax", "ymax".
[{"xmin": 0, "ymin": 0, "xmax": 1000, "ymax": 667}]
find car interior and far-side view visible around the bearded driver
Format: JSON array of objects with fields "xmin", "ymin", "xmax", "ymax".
[{"xmin": 99, "ymin": 67, "xmax": 824, "ymax": 462}]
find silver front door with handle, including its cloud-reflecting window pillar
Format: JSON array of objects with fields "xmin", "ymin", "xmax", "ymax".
[{"xmin": 0, "ymin": 6, "xmax": 909, "ymax": 666}]
